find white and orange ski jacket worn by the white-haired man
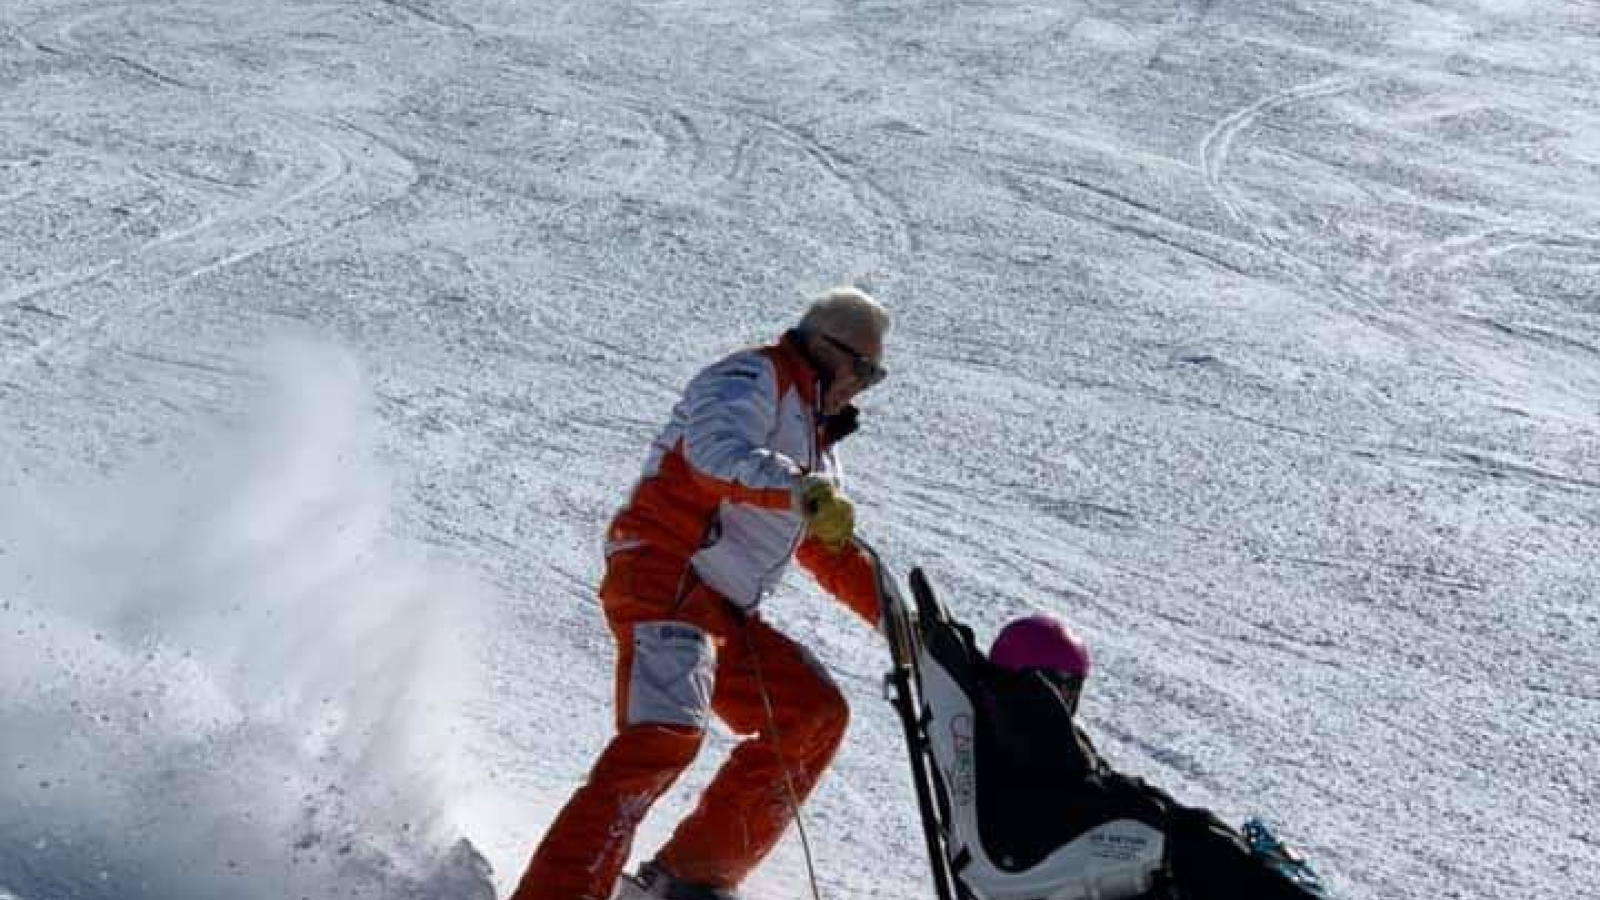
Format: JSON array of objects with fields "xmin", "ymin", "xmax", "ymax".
[{"xmin": 606, "ymin": 331, "xmax": 878, "ymax": 623}]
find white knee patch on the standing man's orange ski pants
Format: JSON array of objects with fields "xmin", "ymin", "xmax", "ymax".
[{"xmin": 624, "ymin": 621, "xmax": 717, "ymax": 729}]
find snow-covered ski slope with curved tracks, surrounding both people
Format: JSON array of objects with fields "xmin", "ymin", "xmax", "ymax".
[{"xmin": 0, "ymin": 0, "xmax": 1600, "ymax": 900}]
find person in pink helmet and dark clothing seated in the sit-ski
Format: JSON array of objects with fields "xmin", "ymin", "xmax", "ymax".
[{"xmin": 982, "ymin": 615, "xmax": 1328, "ymax": 900}]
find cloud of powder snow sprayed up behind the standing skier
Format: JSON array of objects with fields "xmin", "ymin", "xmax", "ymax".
[{"xmin": 0, "ymin": 337, "xmax": 492, "ymax": 900}]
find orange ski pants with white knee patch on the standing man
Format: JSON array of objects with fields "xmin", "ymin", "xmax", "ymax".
[{"xmin": 510, "ymin": 551, "xmax": 850, "ymax": 900}]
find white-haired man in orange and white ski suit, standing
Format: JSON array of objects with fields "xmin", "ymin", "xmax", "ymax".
[{"xmin": 510, "ymin": 288, "xmax": 888, "ymax": 900}]
